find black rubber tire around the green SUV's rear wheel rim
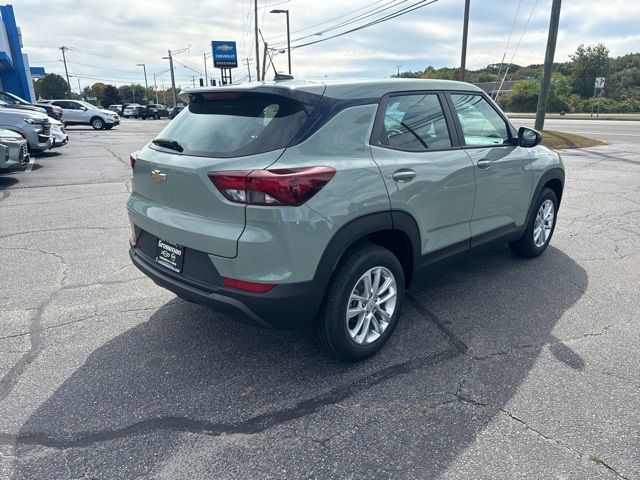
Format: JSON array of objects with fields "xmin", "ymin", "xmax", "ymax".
[{"xmin": 314, "ymin": 243, "xmax": 404, "ymax": 362}]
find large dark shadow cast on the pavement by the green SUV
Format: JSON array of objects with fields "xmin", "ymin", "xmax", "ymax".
[{"xmin": 15, "ymin": 247, "xmax": 588, "ymax": 479}]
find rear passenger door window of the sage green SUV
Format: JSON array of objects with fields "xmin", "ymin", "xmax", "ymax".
[{"xmin": 380, "ymin": 93, "xmax": 451, "ymax": 148}]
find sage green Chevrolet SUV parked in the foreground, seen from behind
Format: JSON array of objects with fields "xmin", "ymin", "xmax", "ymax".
[{"xmin": 127, "ymin": 79, "xmax": 564, "ymax": 360}]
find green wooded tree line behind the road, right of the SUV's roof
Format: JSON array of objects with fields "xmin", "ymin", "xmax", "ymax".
[{"xmin": 393, "ymin": 43, "xmax": 640, "ymax": 113}]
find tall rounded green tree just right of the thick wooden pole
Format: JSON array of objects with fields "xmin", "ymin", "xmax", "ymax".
[{"xmin": 571, "ymin": 43, "xmax": 611, "ymax": 98}]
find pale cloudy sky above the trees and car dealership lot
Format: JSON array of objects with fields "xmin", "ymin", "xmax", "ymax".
[{"xmin": 13, "ymin": 0, "xmax": 640, "ymax": 89}]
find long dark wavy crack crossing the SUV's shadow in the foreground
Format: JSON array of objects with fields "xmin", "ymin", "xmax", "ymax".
[{"xmin": 0, "ymin": 348, "xmax": 460, "ymax": 449}]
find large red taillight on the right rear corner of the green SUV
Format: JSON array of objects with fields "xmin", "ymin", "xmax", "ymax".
[{"xmin": 209, "ymin": 167, "xmax": 336, "ymax": 206}]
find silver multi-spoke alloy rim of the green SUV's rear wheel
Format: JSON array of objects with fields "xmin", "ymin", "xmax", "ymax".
[{"xmin": 346, "ymin": 267, "xmax": 398, "ymax": 345}]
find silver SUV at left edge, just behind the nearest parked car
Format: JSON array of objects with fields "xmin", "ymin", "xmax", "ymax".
[{"xmin": 0, "ymin": 107, "xmax": 53, "ymax": 152}]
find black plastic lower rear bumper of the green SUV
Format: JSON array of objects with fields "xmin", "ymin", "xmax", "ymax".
[{"xmin": 129, "ymin": 246, "xmax": 323, "ymax": 329}]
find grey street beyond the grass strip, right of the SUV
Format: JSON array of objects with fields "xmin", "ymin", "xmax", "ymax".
[{"xmin": 512, "ymin": 118, "xmax": 640, "ymax": 144}]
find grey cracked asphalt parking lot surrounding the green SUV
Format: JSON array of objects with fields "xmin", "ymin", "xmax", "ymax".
[{"xmin": 0, "ymin": 120, "xmax": 640, "ymax": 480}]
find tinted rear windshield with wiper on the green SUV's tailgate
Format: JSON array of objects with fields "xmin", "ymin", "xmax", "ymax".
[{"xmin": 153, "ymin": 92, "xmax": 308, "ymax": 158}]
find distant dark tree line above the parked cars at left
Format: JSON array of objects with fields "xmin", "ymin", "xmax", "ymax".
[{"xmin": 34, "ymin": 73, "xmax": 180, "ymax": 108}]
